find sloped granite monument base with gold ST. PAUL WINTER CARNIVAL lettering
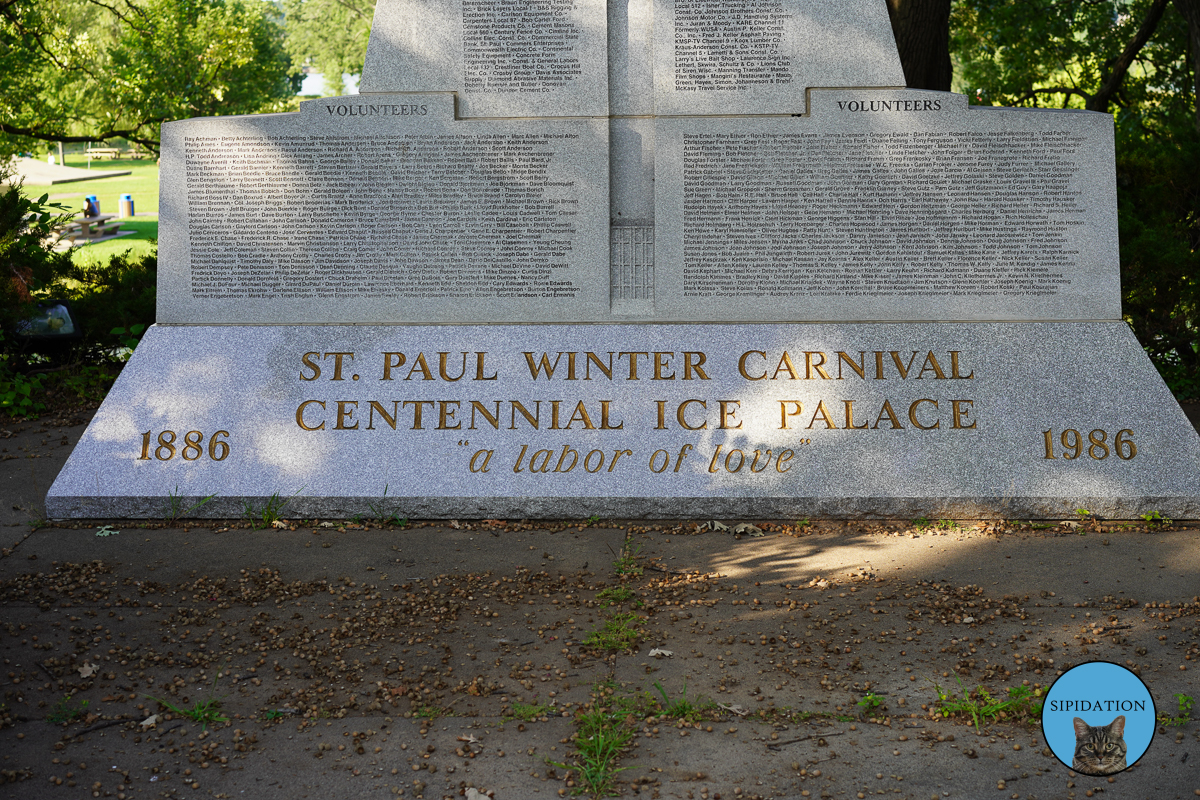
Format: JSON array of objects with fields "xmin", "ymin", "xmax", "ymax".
[{"xmin": 46, "ymin": 321, "xmax": 1200, "ymax": 518}]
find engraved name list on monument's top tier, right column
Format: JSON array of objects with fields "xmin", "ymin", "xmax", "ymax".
[{"xmin": 674, "ymin": 0, "xmax": 792, "ymax": 91}]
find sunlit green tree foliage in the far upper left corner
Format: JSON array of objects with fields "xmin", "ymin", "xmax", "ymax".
[{"xmin": 0, "ymin": 0, "xmax": 295, "ymax": 150}]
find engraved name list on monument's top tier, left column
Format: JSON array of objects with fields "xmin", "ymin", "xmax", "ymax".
[{"xmin": 462, "ymin": 0, "xmax": 583, "ymax": 94}]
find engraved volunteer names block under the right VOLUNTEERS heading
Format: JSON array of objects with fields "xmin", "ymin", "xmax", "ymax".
[{"xmin": 683, "ymin": 132, "xmax": 1085, "ymax": 297}]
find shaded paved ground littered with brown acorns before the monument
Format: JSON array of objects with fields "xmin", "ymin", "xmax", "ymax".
[{"xmin": 0, "ymin": 415, "xmax": 1200, "ymax": 800}]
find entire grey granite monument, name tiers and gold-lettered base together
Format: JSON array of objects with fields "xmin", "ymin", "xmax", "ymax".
[{"xmin": 47, "ymin": 0, "xmax": 1200, "ymax": 518}]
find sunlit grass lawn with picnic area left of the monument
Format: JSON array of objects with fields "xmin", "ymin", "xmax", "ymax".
[{"xmin": 25, "ymin": 156, "xmax": 158, "ymax": 264}]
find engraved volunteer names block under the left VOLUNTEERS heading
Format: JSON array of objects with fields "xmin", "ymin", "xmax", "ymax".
[{"xmin": 185, "ymin": 133, "xmax": 578, "ymax": 300}]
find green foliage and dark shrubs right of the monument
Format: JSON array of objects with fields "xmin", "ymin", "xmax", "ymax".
[{"xmin": 950, "ymin": 0, "xmax": 1200, "ymax": 398}]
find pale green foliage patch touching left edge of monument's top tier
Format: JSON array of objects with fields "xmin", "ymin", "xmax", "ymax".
[{"xmin": 283, "ymin": 0, "xmax": 374, "ymax": 95}]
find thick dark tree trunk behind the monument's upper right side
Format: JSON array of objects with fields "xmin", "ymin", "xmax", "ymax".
[{"xmin": 888, "ymin": 0, "xmax": 945, "ymax": 91}]
